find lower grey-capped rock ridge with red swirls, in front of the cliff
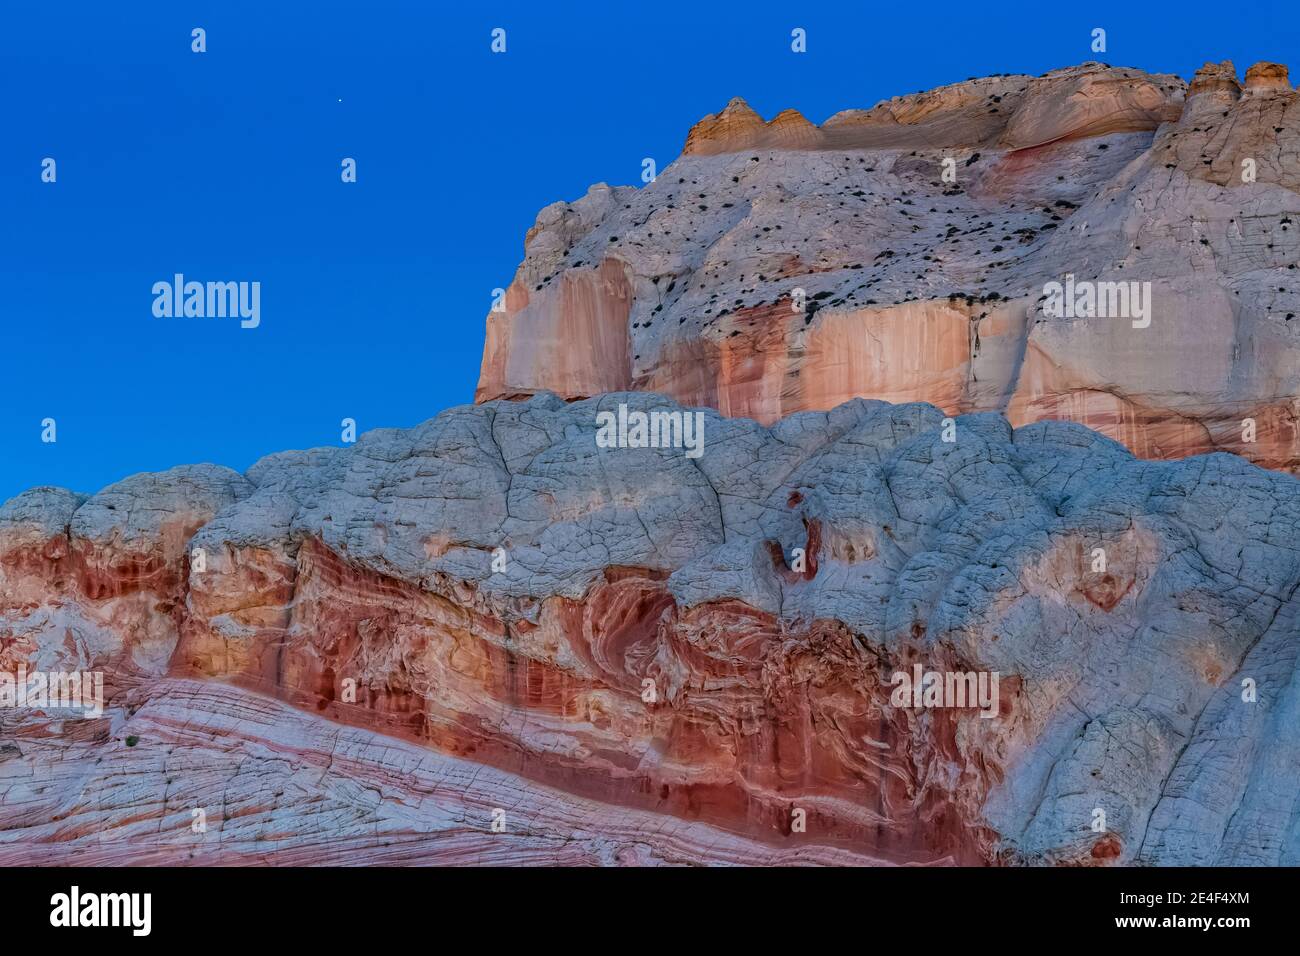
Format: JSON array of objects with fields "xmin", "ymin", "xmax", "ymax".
[{"xmin": 0, "ymin": 393, "xmax": 1300, "ymax": 864}]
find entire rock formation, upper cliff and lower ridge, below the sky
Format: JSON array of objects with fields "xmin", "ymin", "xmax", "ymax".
[{"xmin": 0, "ymin": 64, "xmax": 1300, "ymax": 865}]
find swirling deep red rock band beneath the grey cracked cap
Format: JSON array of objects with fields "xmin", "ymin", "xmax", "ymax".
[{"xmin": 159, "ymin": 540, "xmax": 1014, "ymax": 864}]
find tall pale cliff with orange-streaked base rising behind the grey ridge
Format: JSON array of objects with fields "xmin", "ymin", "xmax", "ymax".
[{"xmin": 477, "ymin": 62, "xmax": 1300, "ymax": 471}]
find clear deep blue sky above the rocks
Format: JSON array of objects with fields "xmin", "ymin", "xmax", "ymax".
[{"xmin": 0, "ymin": 0, "xmax": 1300, "ymax": 499}]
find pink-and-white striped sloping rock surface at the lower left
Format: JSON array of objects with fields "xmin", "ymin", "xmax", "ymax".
[{"xmin": 0, "ymin": 679, "xmax": 883, "ymax": 866}]
